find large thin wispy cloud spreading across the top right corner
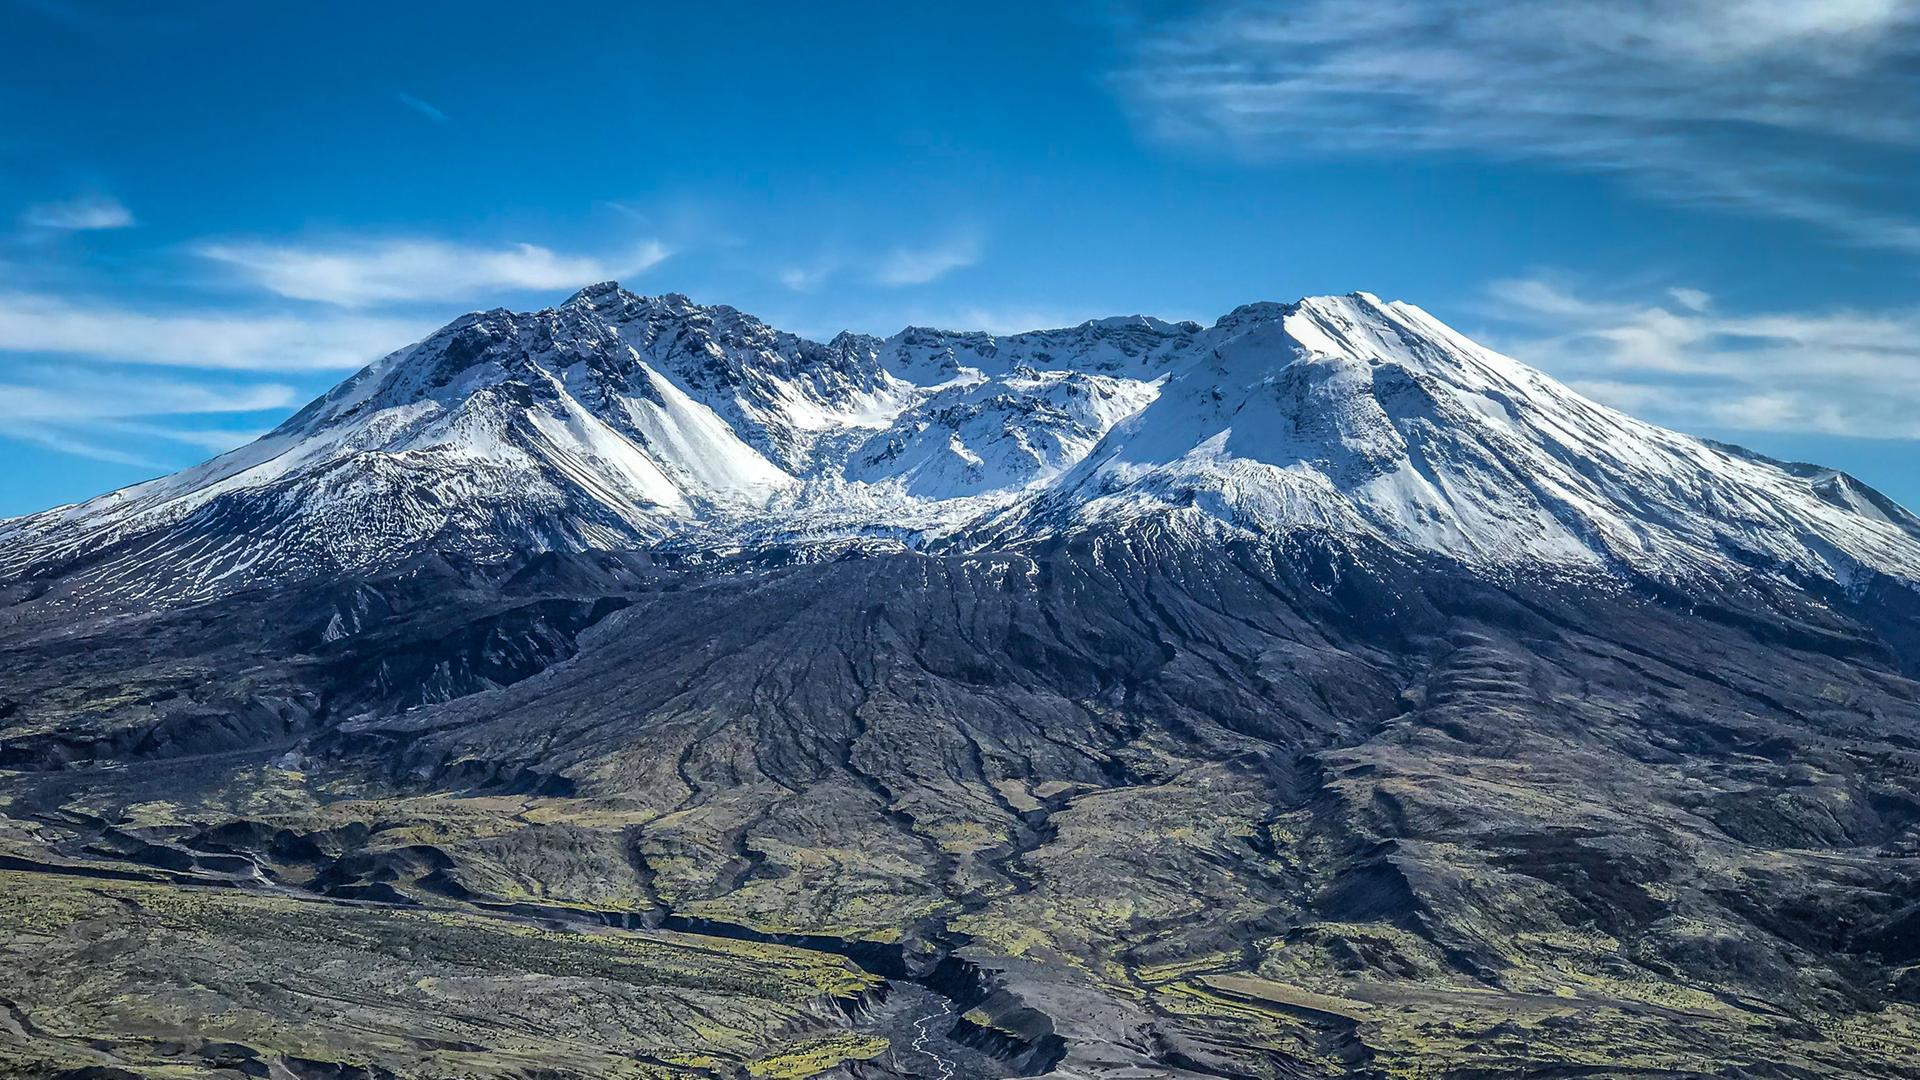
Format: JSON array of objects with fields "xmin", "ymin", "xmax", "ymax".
[{"xmin": 1121, "ymin": 0, "xmax": 1920, "ymax": 252}]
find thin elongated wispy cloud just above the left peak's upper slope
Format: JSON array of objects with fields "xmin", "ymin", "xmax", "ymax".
[{"xmin": 200, "ymin": 240, "xmax": 670, "ymax": 307}]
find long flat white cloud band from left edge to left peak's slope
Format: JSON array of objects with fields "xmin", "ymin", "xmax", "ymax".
[{"xmin": 0, "ymin": 292, "xmax": 432, "ymax": 371}]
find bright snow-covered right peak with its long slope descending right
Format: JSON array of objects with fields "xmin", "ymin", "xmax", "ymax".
[{"xmin": 1014, "ymin": 292, "xmax": 1920, "ymax": 582}]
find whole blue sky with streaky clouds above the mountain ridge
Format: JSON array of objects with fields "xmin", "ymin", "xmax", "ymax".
[{"xmin": 0, "ymin": 0, "xmax": 1920, "ymax": 515}]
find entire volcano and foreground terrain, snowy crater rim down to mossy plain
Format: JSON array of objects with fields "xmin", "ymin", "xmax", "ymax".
[{"xmin": 0, "ymin": 286, "xmax": 1920, "ymax": 1076}]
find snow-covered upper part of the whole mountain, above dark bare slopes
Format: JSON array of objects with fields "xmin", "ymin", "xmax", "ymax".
[{"xmin": 0, "ymin": 282, "xmax": 1920, "ymax": 598}]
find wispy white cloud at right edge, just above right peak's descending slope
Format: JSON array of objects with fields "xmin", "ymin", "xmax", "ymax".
[{"xmin": 1488, "ymin": 279, "xmax": 1920, "ymax": 438}]
